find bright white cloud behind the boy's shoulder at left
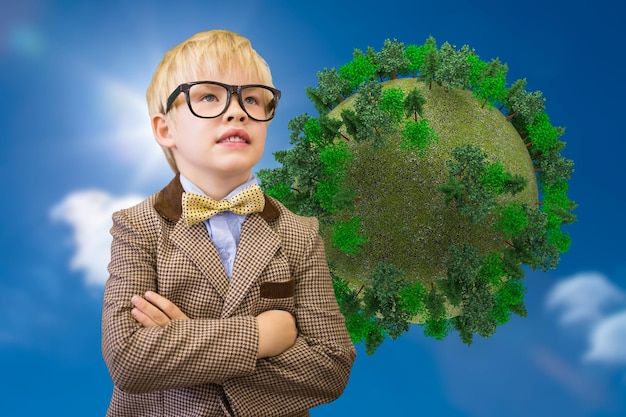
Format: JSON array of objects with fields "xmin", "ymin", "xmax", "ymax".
[{"xmin": 50, "ymin": 190, "xmax": 143, "ymax": 285}]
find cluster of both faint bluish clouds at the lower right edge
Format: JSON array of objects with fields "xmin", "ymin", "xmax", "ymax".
[{"xmin": 546, "ymin": 272, "xmax": 626, "ymax": 365}]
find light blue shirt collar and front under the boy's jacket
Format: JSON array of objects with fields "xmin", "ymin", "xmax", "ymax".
[{"xmin": 180, "ymin": 174, "xmax": 258, "ymax": 279}]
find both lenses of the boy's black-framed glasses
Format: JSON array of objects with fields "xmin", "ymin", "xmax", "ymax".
[{"xmin": 184, "ymin": 84, "xmax": 277, "ymax": 121}]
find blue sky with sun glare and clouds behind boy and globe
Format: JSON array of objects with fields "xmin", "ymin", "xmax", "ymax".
[{"xmin": 0, "ymin": 0, "xmax": 626, "ymax": 417}]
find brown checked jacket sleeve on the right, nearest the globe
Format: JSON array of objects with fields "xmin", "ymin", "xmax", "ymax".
[{"xmin": 224, "ymin": 218, "xmax": 356, "ymax": 417}]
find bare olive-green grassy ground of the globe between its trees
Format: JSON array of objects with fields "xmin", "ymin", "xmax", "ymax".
[{"xmin": 324, "ymin": 78, "xmax": 538, "ymax": 283}]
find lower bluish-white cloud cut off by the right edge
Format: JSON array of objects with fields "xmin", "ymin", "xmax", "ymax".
[{"xmin": 584, "ymin": 311, "xmax": 626, "ymax": 365}]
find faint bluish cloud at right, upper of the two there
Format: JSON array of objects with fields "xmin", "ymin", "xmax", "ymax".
[{"xmin": 546, "ymin": 272, "xmax": 626, "ymax": 325}]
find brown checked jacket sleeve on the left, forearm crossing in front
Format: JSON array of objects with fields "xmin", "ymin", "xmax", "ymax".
[{"xmin": 102, "ymin": 211, "xmax": 258, "ymax": 394}]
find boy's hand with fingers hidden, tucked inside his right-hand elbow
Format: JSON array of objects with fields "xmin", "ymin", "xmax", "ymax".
[{"xmin": 256, "ymin": 310, "xmax": 298, "ymax": 359}]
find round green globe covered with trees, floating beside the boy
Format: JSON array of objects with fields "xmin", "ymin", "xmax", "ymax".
[{"xmin": 258, "ymin": 37, "xmax": 575, "ymax": 354}]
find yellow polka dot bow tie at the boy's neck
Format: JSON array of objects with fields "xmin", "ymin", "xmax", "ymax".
[{"xmin": 183, "ymin": 184, "xmax": 265, "ymax": 226}]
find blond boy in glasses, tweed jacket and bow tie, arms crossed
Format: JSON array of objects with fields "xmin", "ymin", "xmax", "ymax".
[{"xmin": 102, "ymin": 30, "xmax": 356, "ymax": 417}]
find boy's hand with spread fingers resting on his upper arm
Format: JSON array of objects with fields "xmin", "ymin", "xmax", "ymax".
[{"xmin": 130, "ymin": 291, "xmax": 189, "ymax": 327}]
